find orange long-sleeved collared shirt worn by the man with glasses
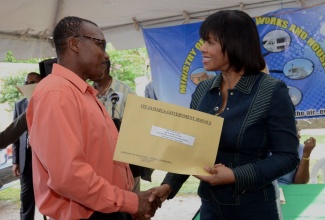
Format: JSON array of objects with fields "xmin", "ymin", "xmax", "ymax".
[{"xmin": 27, "ymin": 64, "xmax": 138, "ymax": 220}]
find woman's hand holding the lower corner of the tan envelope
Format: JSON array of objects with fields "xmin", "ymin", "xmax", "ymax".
[{"xmin": 194, "ymin": 164, "xmax": 236, "ymax": 186}]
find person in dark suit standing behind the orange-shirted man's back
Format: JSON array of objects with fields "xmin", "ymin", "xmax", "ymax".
[{"xmin": 12, "ymin": 72, "xmax": 42, "ymax": 220}]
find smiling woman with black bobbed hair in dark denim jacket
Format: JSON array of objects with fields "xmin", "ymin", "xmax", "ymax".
[{"xmin": 150, "ymin": 10, "xmax": 299, "ymax": 220}]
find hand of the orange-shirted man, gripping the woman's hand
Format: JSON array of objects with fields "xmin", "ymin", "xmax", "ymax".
[{"xmin": 135, "ymin": 190, "xmax": 161, "ymax": 219}]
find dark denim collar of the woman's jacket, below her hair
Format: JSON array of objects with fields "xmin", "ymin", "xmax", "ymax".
[{"xmin": 210, "ymin": 74, "xmax": 259, "ymax": 94}]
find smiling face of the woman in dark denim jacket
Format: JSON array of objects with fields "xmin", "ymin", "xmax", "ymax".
[{"xmin": 200, "ymin": 34, "xmax": 229, "ymax": 71}]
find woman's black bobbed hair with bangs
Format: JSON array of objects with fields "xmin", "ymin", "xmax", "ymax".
[{"xmin": 200, "ymin": 10, "xmax": 265, "ymax": 75}]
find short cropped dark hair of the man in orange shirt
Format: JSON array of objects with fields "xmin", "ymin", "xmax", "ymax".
[{"xmin": 53, "ymin": 16, "xmax": 97, "ymax": 56}]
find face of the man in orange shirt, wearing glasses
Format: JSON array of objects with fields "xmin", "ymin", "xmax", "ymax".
[{"xmin": 77, "ymin": 22, "xmax": 108, "ymax": 81}]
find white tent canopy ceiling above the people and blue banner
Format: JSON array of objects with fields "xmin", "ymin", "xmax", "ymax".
[{"xmin": 0, "ymin": 0, "xmax": 323, "ymax": 60}]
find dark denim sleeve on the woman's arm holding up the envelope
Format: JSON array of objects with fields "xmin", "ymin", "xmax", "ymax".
[{"xmin": 233, "ymin": 81, "xmax": 299, "ymax": 193}]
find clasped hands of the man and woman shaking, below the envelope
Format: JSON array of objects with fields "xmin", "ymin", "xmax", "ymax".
[{"xmin": 135, "ymin": 184, "xmax": 172, "ymax": 220}]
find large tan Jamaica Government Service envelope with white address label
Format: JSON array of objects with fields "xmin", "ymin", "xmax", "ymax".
[{"xmin": 114, "ymin": 94, "xmax": 223, "ymax": 175}]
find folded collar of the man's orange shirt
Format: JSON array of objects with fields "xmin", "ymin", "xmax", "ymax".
[{"xmin": 52, "ymin": 63, "xmax": 97, "ymax": 95}]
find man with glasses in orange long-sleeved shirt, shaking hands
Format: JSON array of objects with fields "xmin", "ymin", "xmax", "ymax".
[{"xmin": 27, "ymin": 17, "xmax": 161, "ymax": 220}]
